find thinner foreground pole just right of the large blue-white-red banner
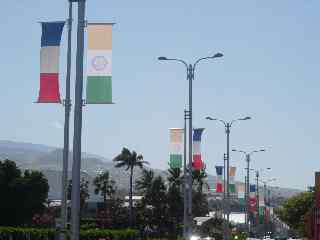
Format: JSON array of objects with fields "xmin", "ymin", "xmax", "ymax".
[{"xmin": 60, "ymin": 1, "xmax": 72, "ymax": 240}]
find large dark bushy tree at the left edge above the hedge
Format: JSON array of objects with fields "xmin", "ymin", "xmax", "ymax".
[{"xmin": 0, "ymin": 160, "xmax": 49, "ymax": 226}]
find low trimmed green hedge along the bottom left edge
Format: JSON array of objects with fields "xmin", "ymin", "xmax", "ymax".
[{"xmin": 0, "ymin": 227, "xmax": 138, "ymax": 240}]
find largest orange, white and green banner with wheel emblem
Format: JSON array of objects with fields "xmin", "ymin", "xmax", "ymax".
[{"xmin": 86, "ymin": 23, "xmax": 113, "ymax": 104}]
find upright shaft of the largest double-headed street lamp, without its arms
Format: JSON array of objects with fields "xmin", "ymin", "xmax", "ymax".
[{"xmin": 188, "ymin": 64, "xmax": 194, "ymax": 236}]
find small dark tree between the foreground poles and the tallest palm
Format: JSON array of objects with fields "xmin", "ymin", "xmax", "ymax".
[{"xmin": 93, "ymin": 171, "xmax": 116, "ymax": 208}]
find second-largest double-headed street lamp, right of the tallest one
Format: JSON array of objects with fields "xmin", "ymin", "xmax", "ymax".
[{"xmin": 206, "ymin": 117, "xmax": 251, "ymax": 240}]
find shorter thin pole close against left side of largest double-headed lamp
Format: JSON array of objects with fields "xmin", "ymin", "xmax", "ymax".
[{"xmin": 183, "ymin": 110, "xmax": 188, "ymax": 239}]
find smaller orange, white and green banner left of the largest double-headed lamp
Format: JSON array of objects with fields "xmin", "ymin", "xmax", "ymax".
[{"xmin": 169, "ymin": 128, "xmax": 184, "ymax": 169}]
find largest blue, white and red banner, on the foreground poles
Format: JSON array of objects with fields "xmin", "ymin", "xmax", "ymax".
[{"xmin": 37, "ymin": 22, "xmax": 65, "ymax": 103}]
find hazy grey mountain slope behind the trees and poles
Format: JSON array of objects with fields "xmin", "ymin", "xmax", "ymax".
[{"xmin": 0, "ymin": 140, "xmax": 300, "ymax": 202}]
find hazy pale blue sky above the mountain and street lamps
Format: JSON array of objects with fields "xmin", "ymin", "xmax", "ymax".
[{"xmin": 0, "ymin": 0, "xmax": 320, "ymax": 189}]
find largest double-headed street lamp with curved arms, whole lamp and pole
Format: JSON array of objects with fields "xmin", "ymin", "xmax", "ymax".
[{"xmin": 158, "ymin": 53, "xmax": 223, "ymax": 237}]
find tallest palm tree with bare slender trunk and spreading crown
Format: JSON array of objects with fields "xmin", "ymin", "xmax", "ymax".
[{"xmin": 113, "ymin": 148, "xmax": 148, "ymax": 226}]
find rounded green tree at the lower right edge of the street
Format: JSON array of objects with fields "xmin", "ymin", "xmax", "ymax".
[{"xmin": 276, "ymin": 191, "xmax": 314, "ymax": 237}]
